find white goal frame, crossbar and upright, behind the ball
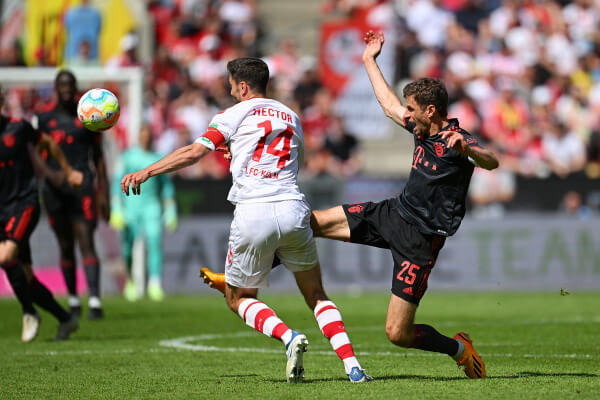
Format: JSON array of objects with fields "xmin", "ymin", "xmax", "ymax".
[{"xmin": 0, "ymin": 67, "xmax": 143, "ymax": 146}]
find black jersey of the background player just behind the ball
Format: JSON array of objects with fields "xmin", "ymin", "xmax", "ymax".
[{"xmin": 38, "ymin": 106, "xmax": 102, "ymax": 175}]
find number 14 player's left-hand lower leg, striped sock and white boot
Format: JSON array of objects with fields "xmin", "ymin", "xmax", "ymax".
[{"xmin": 225, "ymin": 285, "xmax": 308, "ymax": 383}]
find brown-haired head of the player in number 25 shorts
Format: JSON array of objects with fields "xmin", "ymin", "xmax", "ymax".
[{"xmin": 403, "ymin": 78, "xmax": 448, "ymax": 134}]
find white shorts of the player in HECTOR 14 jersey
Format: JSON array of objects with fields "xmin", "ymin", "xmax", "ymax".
[{"xmin": 225, "ymin": 200, "xmax": 318, "ymax": 288}]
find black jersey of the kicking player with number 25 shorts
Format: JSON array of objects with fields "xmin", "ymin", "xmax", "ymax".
[{"xmin": 398, "ymin": 119, "xmax": 481, "ymax": 236}]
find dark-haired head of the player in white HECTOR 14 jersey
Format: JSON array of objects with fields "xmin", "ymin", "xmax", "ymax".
[{"xmin": 227, "ymin": 57, "xmax": 269, "ymax": 101}]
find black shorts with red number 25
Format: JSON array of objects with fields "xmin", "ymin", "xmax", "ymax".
[{"xmin": 342, "ymin": 199, "xmax": 446, "ymax": 304}]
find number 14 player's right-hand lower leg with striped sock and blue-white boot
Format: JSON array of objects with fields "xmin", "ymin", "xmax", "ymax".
[{"xmin": 294, "ymin": 263, "xmax": 373, "ymax": 383}]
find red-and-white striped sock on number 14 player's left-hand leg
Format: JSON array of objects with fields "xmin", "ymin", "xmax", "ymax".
[{"xmin": 238, "ymin": 298, "xmax": 292, "ymax": 346}]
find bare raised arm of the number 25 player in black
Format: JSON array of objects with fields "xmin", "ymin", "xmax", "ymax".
[{"xmin": 362, "ymin": 31, "xmax": 406, "ymax": 126}]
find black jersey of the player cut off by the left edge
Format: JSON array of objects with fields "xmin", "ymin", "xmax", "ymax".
[{"xmin": 0, "ymin": 116, "xmax": 41, "ymax": 208}]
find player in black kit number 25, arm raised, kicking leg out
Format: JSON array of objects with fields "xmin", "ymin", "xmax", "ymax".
[{"xmin": 311, "ymin": 31, "xmax": 498, "ymax": 379}]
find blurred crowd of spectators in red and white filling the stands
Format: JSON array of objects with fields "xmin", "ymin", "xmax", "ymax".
[{"xmin": 4, "ymin": 0, "xmax": 600, "ymax": 212}]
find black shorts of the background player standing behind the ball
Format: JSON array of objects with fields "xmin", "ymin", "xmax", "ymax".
[{"xmin": 42, "ymin": 182, "xmax": 97, "ymax": 224}]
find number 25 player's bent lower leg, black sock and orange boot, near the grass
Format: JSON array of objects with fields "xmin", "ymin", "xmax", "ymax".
[{"xmin": 385, "ymin": 294, "xmax": 486, "ymax": 379}]
